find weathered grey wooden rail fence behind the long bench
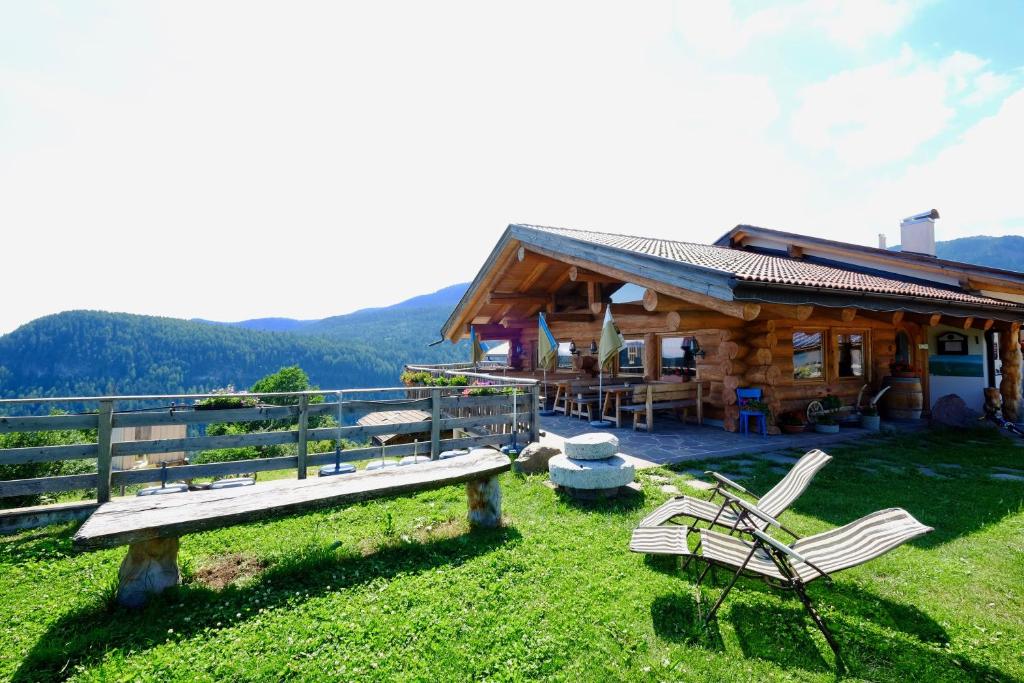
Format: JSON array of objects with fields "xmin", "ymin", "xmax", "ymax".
[{"xmin": 0, "ymin": 375, "xmax": 540, "ymax": 526}]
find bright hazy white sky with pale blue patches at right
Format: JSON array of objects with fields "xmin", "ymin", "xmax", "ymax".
[{"xmin": 0, "ymin": 0, "xmax": 1024, "ymax": 333}]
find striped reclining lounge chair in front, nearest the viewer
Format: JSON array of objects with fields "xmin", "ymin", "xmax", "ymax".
[{"xmin": 696, "ymin": 508, "xmax": 933, "ymax": 667}]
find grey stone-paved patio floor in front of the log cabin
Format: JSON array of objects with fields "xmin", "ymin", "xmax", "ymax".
[{"xmin": 541, "ymin": 415, "xmax": 924, "ymax": 468}]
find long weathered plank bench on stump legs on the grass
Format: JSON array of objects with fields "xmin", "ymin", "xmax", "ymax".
[{"xmin": 74, "ymin": 449, "xmax": 511, "ymax": 607}]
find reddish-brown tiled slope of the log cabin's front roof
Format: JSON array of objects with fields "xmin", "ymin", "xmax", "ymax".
[{"xmin": 524, "ymin": 225, "xmax": 1014, "ymax": 306}]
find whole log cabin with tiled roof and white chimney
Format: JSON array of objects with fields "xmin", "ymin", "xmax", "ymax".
[{"xmin": 441, "ymin": 210, "xmax": 1024, "ymax": 431}]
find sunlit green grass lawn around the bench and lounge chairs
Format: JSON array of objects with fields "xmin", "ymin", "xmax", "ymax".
[{"xmin": 0, "ymin": 433, "xmax": 1024, "ymax": 681}]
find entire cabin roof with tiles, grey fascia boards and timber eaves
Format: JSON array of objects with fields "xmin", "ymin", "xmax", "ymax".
[{"xmin": 441, "ymin": 223, "xmax": 1024, "ymax": 341}]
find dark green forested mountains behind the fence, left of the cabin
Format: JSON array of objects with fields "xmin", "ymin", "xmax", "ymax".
[{"xmin": 0, "ymin": 307, "xmax": 468, "ymax": 397}]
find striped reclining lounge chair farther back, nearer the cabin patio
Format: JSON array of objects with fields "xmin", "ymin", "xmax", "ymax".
[{"xmin": 634, "ymin": 449, "xmax": 831, "ymax": 540}]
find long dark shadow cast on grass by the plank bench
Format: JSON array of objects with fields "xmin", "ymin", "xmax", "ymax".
[{"xmin": 12, "ymin": 526, "xmax": 521, "ymax": 681}]
